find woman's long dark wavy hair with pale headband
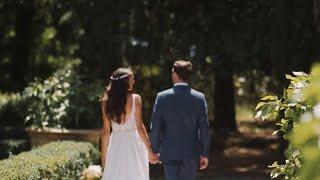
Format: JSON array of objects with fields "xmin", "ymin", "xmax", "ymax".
[{"xmin": 104, "ymin": 68, "xmax": 133, "ymax": 124}]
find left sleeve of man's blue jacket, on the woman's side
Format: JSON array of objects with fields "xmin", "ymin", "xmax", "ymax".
[{"xmin": 150, "ymin": 95, "xmax": 162, "ymax": 153}]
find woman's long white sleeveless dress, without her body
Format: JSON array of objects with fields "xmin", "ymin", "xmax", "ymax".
[{"xmin": 102, "ymin": 98, "xmax": 149, "ymax": 180}]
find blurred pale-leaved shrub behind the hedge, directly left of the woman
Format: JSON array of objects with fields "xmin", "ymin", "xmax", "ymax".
[{"xmin": 23, "ymin": 61, "xmax": 102, "ymax": 128}]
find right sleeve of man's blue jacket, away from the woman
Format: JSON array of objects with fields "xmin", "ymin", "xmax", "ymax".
[{"xmin": 198, "ymin": 97, "xmax": 210, "ymax": 157}]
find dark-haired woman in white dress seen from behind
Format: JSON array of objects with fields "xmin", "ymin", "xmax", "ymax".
[{"xmin": 101, "ymin": 68, "xmax": 157, "ymax": 180}]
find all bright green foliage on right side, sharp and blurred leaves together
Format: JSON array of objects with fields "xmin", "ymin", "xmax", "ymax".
[{"xmin": 256, "ymin": 65, "xmax": 320, "ymax": 180}]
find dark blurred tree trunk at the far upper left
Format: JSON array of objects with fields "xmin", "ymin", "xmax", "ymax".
[{"xmin": 10, "ymin": 0, "xmax": 34, "ymax": 90}]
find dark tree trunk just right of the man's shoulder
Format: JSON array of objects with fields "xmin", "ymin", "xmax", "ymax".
[{"xmin": 213, "ymin": 59, "xmax": 237, "ymax": 134}]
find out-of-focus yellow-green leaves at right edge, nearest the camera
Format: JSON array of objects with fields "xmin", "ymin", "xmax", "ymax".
[{"xmin": 290, "ymin": 64, "xmax": 320, "ymax": 180}]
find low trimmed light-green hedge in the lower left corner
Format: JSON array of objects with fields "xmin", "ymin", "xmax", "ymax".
[{"xmin": 0, "ymin": 141, "xmax": 99, "ymax": 180}]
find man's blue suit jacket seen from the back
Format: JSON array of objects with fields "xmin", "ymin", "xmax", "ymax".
[{"xmin": 151, "ymin": 85, "xmax": 209, "ymax": 160}]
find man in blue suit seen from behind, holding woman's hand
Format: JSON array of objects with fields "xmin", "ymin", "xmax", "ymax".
[{"xmin": 151, "ymin": 61, "xmax": 209, "ymax": 180}]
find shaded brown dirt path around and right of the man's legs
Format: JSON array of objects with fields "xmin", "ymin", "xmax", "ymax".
[{"xmin": 151, "ymin": 121, "xmax": 283, "ymax": 180}]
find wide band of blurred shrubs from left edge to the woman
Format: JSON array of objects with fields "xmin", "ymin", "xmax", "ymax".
[{"xmin": 0, "ymin": 60, "xmax": 103, "ymax": 128}]
